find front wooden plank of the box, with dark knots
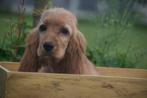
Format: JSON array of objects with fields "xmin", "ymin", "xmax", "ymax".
[{"xmin": 6, "ymin": 72, "xmax": 147, "ymax": 98}]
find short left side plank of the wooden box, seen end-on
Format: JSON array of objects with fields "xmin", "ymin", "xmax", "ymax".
[{"xmin": 0, "ymin": 66, "xmax": 8, "ymax": 98}]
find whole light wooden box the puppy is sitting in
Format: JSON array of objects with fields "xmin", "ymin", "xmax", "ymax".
[{"xmin": 0, "ymin": 62, "xmax": 147, "ymax": 98}]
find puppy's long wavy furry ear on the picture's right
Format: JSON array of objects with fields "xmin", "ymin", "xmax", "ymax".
[{"xmin": 63, "ymin": 32, "xmax": 86, "ymax": 74}]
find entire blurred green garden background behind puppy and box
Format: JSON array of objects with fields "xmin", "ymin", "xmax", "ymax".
[{"xmin": 0, "ymin": 0, "xmax": 147, "ymax": 69}]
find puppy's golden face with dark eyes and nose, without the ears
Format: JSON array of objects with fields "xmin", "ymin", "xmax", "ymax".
[{"xmin": 37, "ymin": 9, "xmax": 75, "ymax": 60}]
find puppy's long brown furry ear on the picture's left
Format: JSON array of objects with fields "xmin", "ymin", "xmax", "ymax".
[{"xmin": 19, "ymin": 29, "xmax": 39, "ymax": 72}]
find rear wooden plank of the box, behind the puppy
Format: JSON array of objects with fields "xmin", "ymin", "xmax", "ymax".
[{"xmin": 0, "ymin": 62, "xmax": 147, "ymax": 78}]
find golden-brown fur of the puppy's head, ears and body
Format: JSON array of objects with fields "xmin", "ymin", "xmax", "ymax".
[{"xmin": 19, "ymin": 8, "xmax": 97, "ymax": 75}]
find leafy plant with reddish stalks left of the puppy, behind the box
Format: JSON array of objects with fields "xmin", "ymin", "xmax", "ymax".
[{"xmin": 0, "ymin": 0, "xmax": 27, "ymax": 61}]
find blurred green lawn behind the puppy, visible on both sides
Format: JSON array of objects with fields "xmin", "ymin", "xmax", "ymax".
[{"xmin": 0, "ymin": 13, "xmax": 147, "ymax": 68}]
